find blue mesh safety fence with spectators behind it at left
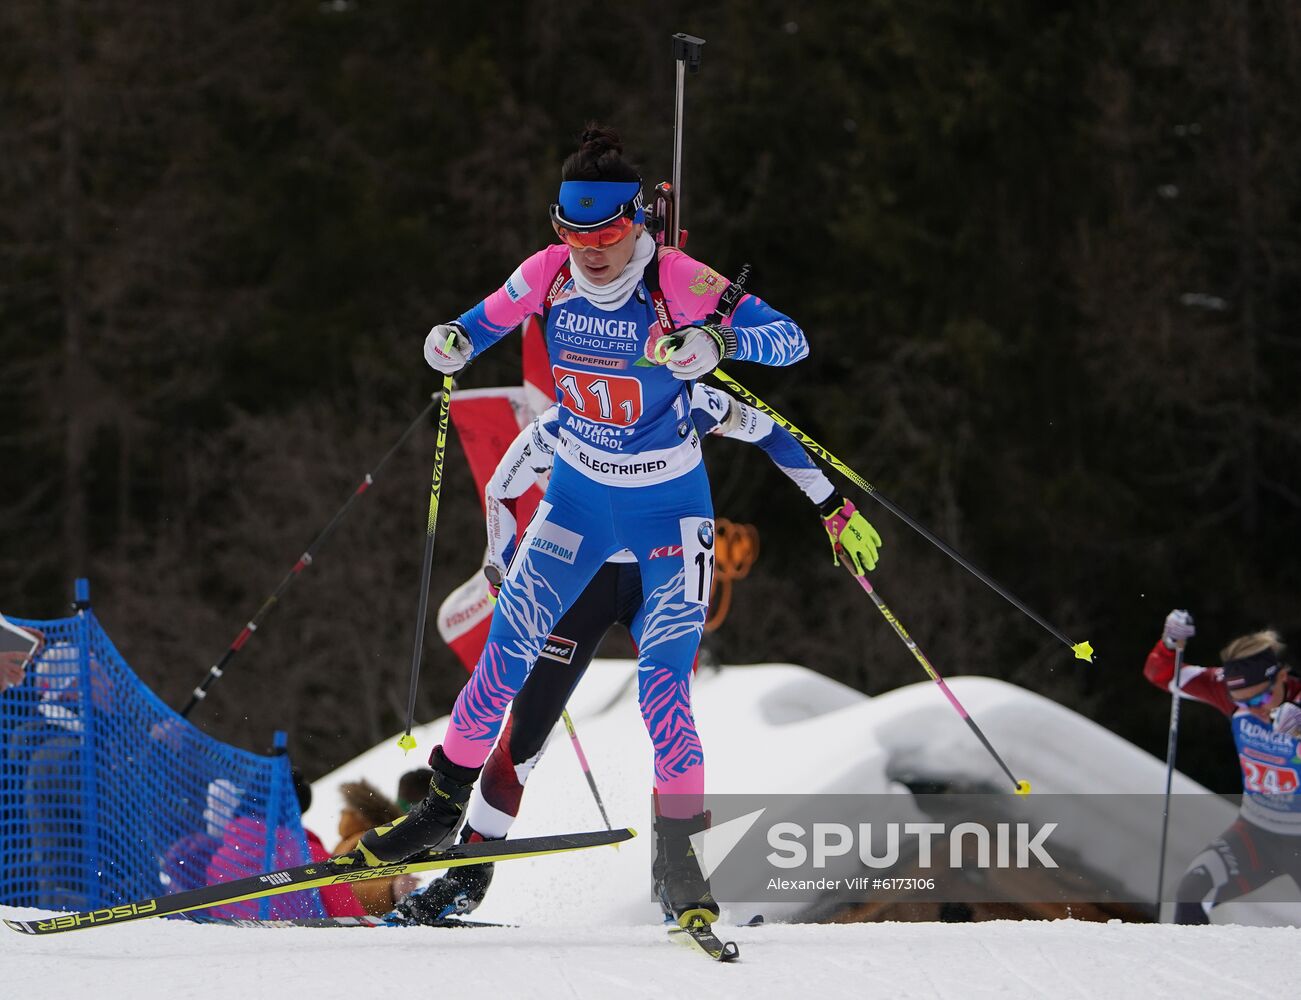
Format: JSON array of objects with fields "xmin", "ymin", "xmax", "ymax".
[{"xmin": 0, "ymin": 580, "xmax": 324, "ymax": 919}]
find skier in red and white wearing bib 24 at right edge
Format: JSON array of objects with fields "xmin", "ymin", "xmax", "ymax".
[{"xmin": 1144, "ymin": 611, "xmax": 1301, "ymax": 923}]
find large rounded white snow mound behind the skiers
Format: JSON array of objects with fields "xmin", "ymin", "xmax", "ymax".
[{"xmin": 306, "ymin": 661, "xmax": 1248, "ymax": 926}]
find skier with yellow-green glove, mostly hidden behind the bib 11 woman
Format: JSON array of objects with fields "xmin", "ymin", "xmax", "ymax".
[{"xmin": 385, "ymin": 385, "xmax": 881, "ymax": 925}]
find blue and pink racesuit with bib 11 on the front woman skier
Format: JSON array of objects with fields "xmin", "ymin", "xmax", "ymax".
[{"xmin": 442, "ymin": 234, "xmax": 808, "ymax": 815}]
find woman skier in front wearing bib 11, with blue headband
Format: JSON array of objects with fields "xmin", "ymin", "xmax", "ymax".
[{"xmin": 359, "ymin": 126, "xmax": 808, "ymax": 925}]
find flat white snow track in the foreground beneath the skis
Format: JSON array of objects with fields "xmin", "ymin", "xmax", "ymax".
[{"xmin": 0, "ymin": 908, "xmax": 1296, "ymax": 1000}]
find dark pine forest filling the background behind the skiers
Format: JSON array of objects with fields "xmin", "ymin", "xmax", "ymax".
[{"xmin": 0, "ymin": 0, "xmax": 1301, "ymax": 791}]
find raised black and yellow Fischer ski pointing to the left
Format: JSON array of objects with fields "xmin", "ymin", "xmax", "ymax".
[{"xmin": 5, "ymin": 827, "xmax": 636, "ymax": 935}]
